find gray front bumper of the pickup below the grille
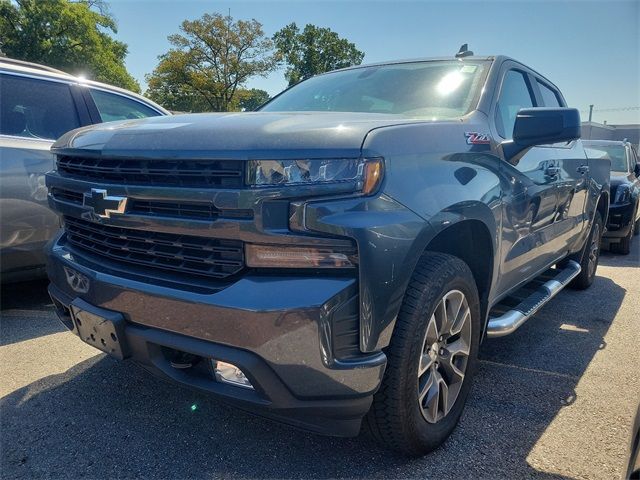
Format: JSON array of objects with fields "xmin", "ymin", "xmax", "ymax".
[{"xmin": 47, "ymin": 238, "xmax": 386, "ymax": 436}]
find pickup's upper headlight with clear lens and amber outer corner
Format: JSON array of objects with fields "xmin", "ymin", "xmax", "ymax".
[{"xmin": 247, "ymin": 158, "xmax": 383, "ymax": 194}]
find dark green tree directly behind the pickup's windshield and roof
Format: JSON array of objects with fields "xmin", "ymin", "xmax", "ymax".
[{"xmin": 273, "ymin": 23, "xmax": 364, "ymax": 86}]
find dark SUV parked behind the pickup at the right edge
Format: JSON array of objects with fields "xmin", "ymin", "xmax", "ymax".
[{"xmin": 584, "ymin": 140, "xmax": 640, "ymax": 255}]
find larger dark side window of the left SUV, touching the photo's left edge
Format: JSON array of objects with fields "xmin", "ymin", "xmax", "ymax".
[{"xmin": 0, "ymin": 74, "xmax": 80, "ymax": 140}]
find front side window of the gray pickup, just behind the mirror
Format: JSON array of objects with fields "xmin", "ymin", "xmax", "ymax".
[{"xmin": 496, "ymin": 70, "xmax": 533, "ymax": 138}]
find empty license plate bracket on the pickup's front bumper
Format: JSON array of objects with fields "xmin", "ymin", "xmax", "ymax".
[{"xmin": 70, "ymin": 298, "xmax": 129, "ymax": 360}]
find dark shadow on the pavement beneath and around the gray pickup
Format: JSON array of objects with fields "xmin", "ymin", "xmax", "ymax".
[{"xmin": 0, "ymin": 277, "xmax": 625, "ymax": 478}]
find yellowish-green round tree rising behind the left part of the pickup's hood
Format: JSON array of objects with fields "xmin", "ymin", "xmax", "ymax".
[{"xmin": 146, "ymin": 13, "xmax": 277, "ymax": 112}]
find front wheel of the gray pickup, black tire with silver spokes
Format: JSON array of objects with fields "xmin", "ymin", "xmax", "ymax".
[{"xmin": 366, "ymin": 253, "xmax": 481, "ymax": 455}]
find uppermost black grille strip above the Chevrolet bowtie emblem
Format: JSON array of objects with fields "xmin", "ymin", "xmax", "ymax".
[{"xmin": 57, "ymin": 155, "xmax": 244, "ymax": 188}]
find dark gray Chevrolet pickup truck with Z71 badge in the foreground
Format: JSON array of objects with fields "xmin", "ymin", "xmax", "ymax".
[{"xmin": 46, "ymin": 53, "xmax": 610, "ymax": 455}]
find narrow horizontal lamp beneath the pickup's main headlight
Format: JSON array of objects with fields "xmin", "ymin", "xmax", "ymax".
[{"xmin": 245, "ymin": 244, "xmax": 353, "ymax": 268}]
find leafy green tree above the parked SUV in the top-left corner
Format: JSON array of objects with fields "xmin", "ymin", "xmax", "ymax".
[{"xmin": 0, "ymin": 0, "xmax": 140, "ymax": 92}]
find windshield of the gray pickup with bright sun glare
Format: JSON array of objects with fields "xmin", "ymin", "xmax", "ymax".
[{"xmin": 261, "ymin": 60, "xmax": 488, "ymax": 120}]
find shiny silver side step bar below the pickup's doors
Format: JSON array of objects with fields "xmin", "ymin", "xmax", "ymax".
[{"xmin": 487, "ymin": 260, "xmax": 581, "ymax": 337}]
